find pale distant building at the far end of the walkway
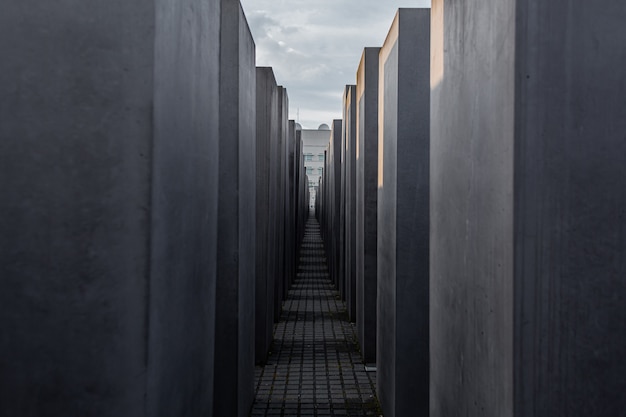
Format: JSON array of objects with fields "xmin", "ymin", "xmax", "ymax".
[{"xmin": 302, "ymin": 124, "xmax": 330, "ymax": 206}]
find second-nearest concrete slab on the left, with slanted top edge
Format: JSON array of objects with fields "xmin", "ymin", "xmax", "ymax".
[{"xmin": 214, "ymin": 0, "xmax": 256, "ymax": 417}]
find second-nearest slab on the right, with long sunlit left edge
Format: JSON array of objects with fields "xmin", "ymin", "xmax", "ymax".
[{"xmin": 376, "ymin": 9, "xmax": 430, "ymax": 417}]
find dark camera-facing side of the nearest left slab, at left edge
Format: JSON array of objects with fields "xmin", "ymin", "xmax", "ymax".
[{"xmin": 0, "ymin": 1, "xmax": 155, "ymax": 416}]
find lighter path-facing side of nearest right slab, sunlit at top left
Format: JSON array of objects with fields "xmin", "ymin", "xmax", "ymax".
[{"xmin": 431, "ymin": 1, "xmax": 515, "ymax": 417}]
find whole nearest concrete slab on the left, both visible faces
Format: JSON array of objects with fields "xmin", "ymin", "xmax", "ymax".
[{"xmin": 0, "ymin": 0, "xmax": 220, "ymax": 417}]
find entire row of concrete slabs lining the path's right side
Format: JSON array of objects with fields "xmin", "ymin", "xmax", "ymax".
[{"xmin": 316, "ymin": 5, "xmax": 626, "ymax": 417}]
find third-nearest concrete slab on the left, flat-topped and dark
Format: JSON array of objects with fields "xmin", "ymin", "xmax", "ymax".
[{"xmin": 255, "ymin": 67, "xmax": 278, "ymax": 363}]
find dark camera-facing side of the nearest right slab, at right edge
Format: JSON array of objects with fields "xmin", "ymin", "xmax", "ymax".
[{"xmin": 513, "ymin": 0, "xmax": 626, "ymax": 417}]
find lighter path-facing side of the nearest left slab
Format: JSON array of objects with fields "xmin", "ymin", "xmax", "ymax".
[{"xmin": 146, "ymin": 0, "xmax": 220, "ymax": 417}]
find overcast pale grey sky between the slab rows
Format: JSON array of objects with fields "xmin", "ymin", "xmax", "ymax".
[{"xmin": 241, "ymin": 0, "xmax": 430, "ymax": 129}]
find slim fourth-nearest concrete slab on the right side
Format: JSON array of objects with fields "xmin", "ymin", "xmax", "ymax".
[{"xmin": 343, "ymin": 85, "xmax": 356, "ymax": 322}]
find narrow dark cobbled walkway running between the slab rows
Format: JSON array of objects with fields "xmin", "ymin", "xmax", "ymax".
[{"xmin": 251, "ymin": 217, "xmax": 380, "ymax": 417}]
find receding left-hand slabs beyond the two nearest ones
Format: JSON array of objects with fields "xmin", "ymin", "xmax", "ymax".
[{"xmin": 255, "ymin": 67, "xmax": 310, "ymax": 364}]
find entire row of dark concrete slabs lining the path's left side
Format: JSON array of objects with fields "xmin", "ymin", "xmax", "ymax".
[{"xmin": 0, "ymin": 0, "xmax": 308, "ymax": 417}]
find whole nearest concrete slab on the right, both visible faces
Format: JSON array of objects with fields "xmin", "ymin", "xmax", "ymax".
[{"xmin": 430, "ymin": 0, "xmax": 626, "ymax": 417}]
